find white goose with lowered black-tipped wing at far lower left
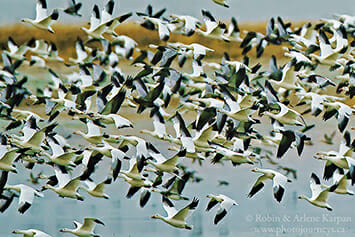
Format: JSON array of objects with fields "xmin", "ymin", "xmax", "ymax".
[{"xmin": 4, "ymin": 184, "xmax": 43, "ymax": 214}]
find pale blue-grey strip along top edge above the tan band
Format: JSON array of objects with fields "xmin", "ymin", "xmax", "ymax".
[{"xmin": 0, "ymin": 0, "xmax": 355, "ymax": 25}]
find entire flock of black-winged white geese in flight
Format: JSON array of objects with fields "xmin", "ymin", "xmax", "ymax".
[{"xmin": 0, "ymin": 0, "xmax": 355, "ymax": 237}]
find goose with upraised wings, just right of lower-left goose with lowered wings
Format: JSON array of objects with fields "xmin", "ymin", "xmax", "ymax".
[{"xmin": 43, "ymin": 166, "xmax": 84, "ymax": 201}]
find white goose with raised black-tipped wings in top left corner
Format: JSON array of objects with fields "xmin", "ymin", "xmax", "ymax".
[{"xmin": 22, "ymin": 0, "xmax": 59, "ymax": 33}]
